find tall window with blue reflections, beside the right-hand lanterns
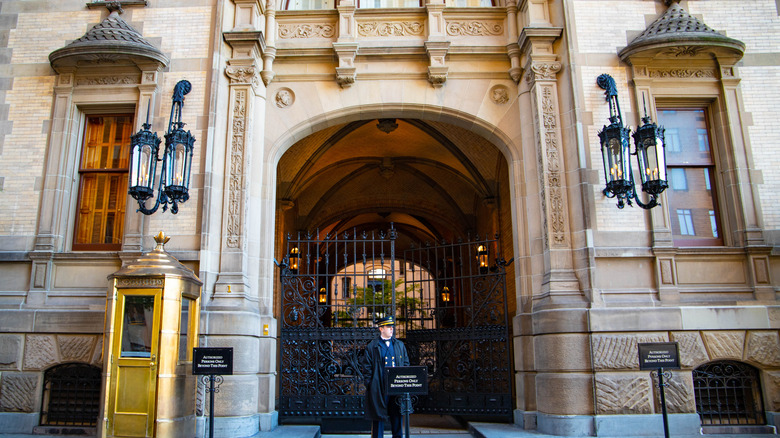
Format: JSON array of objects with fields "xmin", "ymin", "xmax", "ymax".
[{"xmin": 658, "ymin": 108, "xmax": 723, "ymax": 246}]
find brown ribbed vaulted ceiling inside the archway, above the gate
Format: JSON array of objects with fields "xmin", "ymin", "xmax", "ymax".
[{"xmin": 277, "ymin": 119, "xmax": 506, "ymax": 245}]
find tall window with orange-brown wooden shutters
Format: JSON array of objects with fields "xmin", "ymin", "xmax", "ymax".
[{"xmin": 73, "ymin": 114, "xmax": 133, "ymax": 251}]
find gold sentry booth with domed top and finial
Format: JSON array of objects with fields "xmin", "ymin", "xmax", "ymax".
[{"xmin": 98, "ymin": 231, "xmax": 203, "ymax": 438}]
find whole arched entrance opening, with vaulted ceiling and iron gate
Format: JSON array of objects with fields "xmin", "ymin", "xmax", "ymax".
[{"xmin": 276, "ymin": 118, "xmax": 515, "ymax": 432}]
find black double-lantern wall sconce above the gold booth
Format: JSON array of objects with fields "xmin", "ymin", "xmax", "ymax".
[{"xmin": 127, "ymin": 81, "xmax": 195, "ymax": 215}]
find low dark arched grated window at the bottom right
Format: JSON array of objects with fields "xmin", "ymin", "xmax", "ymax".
[{"xmin": 693, "ymin": 360, "xmax": 766, "ymax": 426}]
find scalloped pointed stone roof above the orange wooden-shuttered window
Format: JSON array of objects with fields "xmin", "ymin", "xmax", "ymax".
[{"xmin": 49, "ymin": 10, "xmax": 169, "ymax": 70}]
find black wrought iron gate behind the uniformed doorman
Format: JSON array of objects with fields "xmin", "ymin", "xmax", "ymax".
[{"xmin": 278, "ymin": 227, "xmax": 512, "ymax": 424}]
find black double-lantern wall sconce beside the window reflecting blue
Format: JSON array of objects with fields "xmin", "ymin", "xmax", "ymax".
[{"xmin": 596, "ymin": 74, "xmax": 669, "ymax": 210}]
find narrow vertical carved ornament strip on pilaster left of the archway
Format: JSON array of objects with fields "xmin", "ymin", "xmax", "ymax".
[{"xmin": 227, "ymin": 90, "xmax": 247, "ymax": 248}]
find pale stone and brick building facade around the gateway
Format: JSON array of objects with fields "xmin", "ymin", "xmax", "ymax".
[{"xmin": 0, "ymin": 0, "xmax": 780, "ymax": 437}]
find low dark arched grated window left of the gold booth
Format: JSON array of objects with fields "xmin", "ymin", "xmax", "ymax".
[{"xmin": 41, "ymin": 363, "xmax": 100, "ymax": 427}]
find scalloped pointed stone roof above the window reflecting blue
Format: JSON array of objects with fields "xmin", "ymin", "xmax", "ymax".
[{"xmin": 620, "ymin": 3, "xmax": 745, "ymax": 60}]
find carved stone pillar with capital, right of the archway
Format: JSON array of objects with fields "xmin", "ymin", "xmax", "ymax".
[{"xmin": 519, "ymin": 27, "xmax": 587, "ymax": 310}]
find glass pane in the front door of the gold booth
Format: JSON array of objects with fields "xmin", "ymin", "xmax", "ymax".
[{"xmin": 121, "ymin": 296, "xmax": 154, "ymax": 357}]
